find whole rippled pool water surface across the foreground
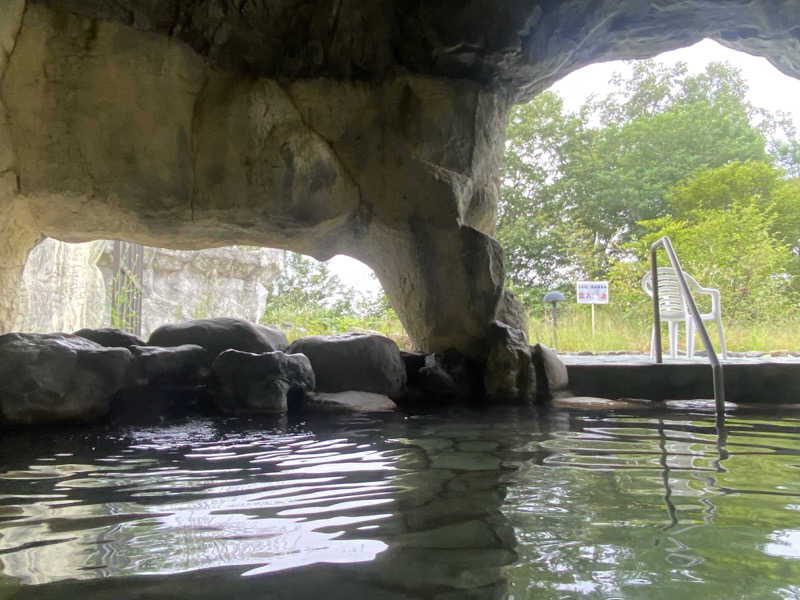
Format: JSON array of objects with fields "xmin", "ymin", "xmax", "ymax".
[{"xmin": 0, "ymin": 405, "xmax": 800, "ymax": 600}]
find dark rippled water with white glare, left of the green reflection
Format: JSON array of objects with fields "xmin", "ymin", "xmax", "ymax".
[{"xmin": 0, "ymin": 417, "xmax": 516, "ymax": 598}]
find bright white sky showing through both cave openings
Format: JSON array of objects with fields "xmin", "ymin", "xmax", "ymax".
[{"xmin": 329, "ymin": 40, "xmax": 800, "ymax": 292}]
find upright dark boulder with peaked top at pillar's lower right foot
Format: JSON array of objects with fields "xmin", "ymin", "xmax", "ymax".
[{"xmin": 483, "ymin": 321, "xmax": 536, "ymax": 402}]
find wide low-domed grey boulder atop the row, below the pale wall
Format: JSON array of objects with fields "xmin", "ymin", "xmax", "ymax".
[{"xmin": 148, "ymin": 317, "xmax": 288, "ymax": 358}]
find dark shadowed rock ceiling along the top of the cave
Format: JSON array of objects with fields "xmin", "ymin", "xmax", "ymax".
[{"xmin": 35, "ymin": 0, "xmax": 800, "ymax": 100}]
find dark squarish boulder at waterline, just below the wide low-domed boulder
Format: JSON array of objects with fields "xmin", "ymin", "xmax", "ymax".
[{"xmin": 211, "ymin": 350, "xmax": 314, "ymax": 414}]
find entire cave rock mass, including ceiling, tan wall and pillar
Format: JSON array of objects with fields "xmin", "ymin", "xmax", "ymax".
[{"xmin": 0, "ymin": 0, "xmax": 800, "ymax": 358}]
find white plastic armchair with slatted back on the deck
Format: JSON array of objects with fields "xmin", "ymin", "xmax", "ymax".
[{"xmin": 641, "ymin": 267, "xmax": 728, "ymax": 358}]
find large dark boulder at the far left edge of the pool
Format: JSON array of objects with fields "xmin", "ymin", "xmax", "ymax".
[{"xmin": 0, "ymin": 333, "xmax": 131, "ymax": 424}]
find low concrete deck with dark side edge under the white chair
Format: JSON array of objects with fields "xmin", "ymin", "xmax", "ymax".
[{"xmin": 559, "ymin": 353, "xmax": 800, "ymax": 404}]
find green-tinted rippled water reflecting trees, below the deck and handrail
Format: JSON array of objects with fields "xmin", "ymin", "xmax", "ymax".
[{"xmin": 507, "ymin": 414, "xmax": 800, "ymax": 598}]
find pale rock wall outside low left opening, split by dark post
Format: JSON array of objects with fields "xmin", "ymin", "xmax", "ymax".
[{"xmin": 14, "ymin": 238, "xmax": 280, "ymax": 339}]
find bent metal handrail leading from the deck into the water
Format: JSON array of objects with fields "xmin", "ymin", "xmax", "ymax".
[{"xmin": 650, "ymin": 235, "xmax": 725, "ymax": 421}]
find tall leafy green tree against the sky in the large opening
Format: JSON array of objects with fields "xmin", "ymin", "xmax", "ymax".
[{"xmin": 497, "ymin": 61, "xmax": 794, "ymax": 306}]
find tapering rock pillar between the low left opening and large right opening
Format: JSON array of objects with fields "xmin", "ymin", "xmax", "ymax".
[{"xmin": 287, "ymin": 74, "xmax": 508, "ymax": 358}]
